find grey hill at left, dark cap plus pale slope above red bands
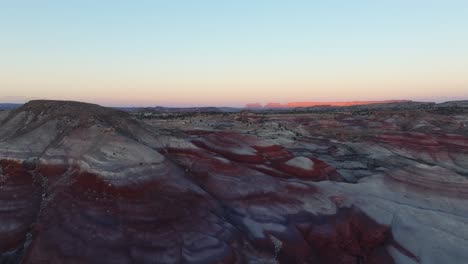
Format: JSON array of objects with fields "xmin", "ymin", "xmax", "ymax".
[{"xmin": 0, "ymin": 100, "xmax": 164, "ymax": 178}]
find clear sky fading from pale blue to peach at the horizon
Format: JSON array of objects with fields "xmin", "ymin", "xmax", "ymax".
[{"xmin": 0, "ymin": 0, "xmax": 468, "ymax": 106}]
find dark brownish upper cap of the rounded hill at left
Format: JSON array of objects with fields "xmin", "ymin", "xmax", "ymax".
[{"xmin": 0, "ymin": 100, "xmax": 141, "ymax": 149}]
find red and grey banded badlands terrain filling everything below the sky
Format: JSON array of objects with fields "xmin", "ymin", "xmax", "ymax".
[{"xmin": 0, "ymin": 101, "xmax": 468, "ymax": 264}]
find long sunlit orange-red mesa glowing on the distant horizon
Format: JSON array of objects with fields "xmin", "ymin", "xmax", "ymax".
[{"xmin": 245, "ymin": 100, "xmax": 411, "ymax": 109}]
